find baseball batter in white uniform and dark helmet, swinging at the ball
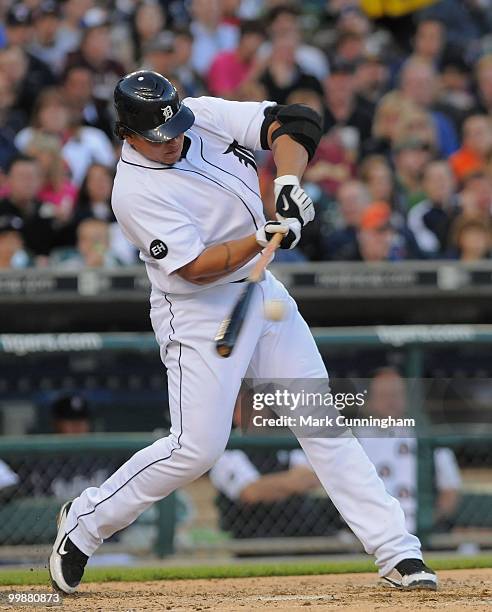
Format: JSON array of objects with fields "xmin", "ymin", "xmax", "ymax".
[{"xmin": 49, "ymin": 71, "xmax": 437, "ymax": 593}]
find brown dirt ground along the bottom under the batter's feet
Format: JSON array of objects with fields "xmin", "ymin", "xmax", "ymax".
[{"xmin": 0, "ymin": 569, "xmax": 492, "ymax": 612}]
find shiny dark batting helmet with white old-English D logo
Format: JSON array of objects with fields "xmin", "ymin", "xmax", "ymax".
[{"xmin": 114, "ymin": 70, "xmax": 195, "ymax": 142}]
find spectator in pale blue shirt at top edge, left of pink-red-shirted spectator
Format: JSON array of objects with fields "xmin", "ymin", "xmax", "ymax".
[{"xmin": 190, "ymin": 0, "xmax": 239, "ymax": 76}]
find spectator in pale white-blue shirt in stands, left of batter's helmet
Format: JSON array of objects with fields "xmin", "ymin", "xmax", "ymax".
[{"xmin": 15, "ymin": 88, "xmax": 115, "ymax": 185}]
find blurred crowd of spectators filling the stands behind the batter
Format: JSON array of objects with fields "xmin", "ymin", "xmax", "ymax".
[{"xmin": 0, "ymin": 0, "xmax": 492, "ymax": 269}]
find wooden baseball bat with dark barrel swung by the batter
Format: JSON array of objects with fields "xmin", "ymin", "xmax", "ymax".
[{"xmin": 215, "ymin": 232, "xmax": 285, "ymax": 357}]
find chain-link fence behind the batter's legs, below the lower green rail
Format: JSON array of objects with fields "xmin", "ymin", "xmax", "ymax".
[{"xmin": 0, "ymin": 435, "xmax": 492, "ymax": 556}]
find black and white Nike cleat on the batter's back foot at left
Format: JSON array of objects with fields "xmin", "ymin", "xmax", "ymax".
[{"xmin": 49, "ymin": 502, "xmax": 89, "ymax": 593}]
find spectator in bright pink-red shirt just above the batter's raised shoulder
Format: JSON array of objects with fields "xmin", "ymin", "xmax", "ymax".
[{"xmin": 207, "ymin": 21, "xmax": 265, "ymax": 99}]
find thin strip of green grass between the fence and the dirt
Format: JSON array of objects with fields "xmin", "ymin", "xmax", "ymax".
[{"xmin": 0, "ymin": 556, "xmax": 492, "ymax": 586}]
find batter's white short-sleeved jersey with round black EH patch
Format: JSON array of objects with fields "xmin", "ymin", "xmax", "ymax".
[{"xmin": 112, "ymin": 97, "xmax": 273, "ymax": 293}]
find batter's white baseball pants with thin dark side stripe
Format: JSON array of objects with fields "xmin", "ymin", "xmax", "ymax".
[{"xmin": 67, "ymin": 273, "xmax": 422, "ymax": 575}]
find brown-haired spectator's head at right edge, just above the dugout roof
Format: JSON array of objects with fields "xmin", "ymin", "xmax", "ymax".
[{"xmin": 451, "ymin": 216, "xmax": 492, "ymax": 262}]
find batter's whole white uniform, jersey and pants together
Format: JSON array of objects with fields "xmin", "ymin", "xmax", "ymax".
[{"xmin": 66, "ymin": 93, "xmax": 421, "ymax": 575}]
